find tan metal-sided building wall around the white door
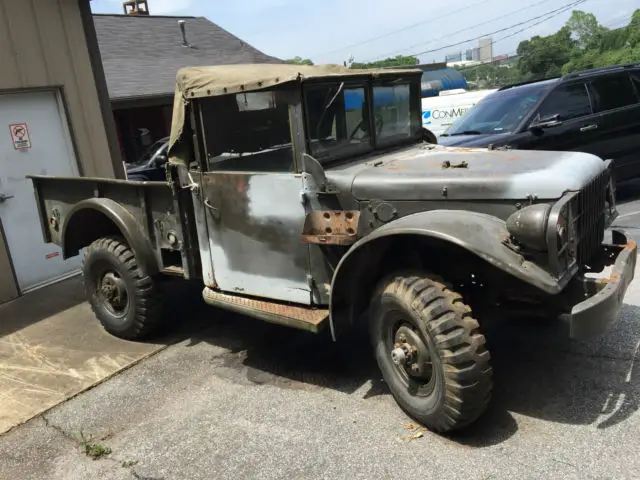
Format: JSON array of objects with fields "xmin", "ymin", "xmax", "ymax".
[{"xmin": 0, "ymin": 0, "xmax": 123, "ymax": 299}]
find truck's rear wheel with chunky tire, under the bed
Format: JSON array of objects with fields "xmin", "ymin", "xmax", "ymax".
[{"xmin": 82, "ymin": 237, "xmax": 161, "ymax": 340}]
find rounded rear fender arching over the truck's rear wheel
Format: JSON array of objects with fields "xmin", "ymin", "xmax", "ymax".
[{"xmin": 61, "ymin": 198, "xmax": 160, "ymax": 275}]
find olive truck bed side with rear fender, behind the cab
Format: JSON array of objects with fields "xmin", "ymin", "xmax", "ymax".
[{"xmin": 29, "ymin": 171, "xmax": 201, "ymax": 278}]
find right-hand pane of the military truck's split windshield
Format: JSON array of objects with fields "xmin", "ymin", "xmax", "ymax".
[{"xmin": 373, "ymin": 85, "xmax": 413, "ymax": 143}]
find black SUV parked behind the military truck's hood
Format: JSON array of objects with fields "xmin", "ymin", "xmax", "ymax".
[{"xmin": 438, "ymin": 63, "xmax": 640, "ymax": 182}]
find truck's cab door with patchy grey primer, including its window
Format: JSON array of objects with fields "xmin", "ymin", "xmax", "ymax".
[{"xmin": 199, "ymin": 91, "xmax": 312, "ymax": 305}]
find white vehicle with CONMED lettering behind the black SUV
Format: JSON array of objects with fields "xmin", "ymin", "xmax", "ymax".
[{"xmin": 422, "ymin": 89, "xmax": 497, "ymax": 138}]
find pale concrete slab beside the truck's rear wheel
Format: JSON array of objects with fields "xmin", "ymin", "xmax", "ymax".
[{"xmin": 0, "ymin": 277, "xmax": 199, "ymax": 434}]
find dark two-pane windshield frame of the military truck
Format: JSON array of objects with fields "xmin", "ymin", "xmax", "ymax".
[{"xmin": 302, "ymin": 75, "xmax": 423, "ymax": 164}]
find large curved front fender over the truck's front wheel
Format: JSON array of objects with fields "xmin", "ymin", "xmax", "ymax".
[{"xmin": 329, "ymin": 210, "xmax": 562, "ymax": 338}]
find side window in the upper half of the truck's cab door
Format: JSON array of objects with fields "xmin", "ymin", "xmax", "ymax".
[{"xmin": 200, "ymin": 90, "xmax": 293, "ymax": 172}]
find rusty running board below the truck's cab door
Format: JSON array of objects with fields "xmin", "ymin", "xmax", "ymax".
[{"xmin": 202, "ymin": 287, "xmax": 329, "ymax": 333}]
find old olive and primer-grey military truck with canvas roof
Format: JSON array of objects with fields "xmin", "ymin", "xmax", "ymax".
[{"xmin": 31, "ymin": 65, "xmax": 636, "ymax": 432}]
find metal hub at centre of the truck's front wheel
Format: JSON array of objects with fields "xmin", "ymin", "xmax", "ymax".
[{"xmin": 391, "ymin": 325, "xmax": 431, "ymax": 379}]
